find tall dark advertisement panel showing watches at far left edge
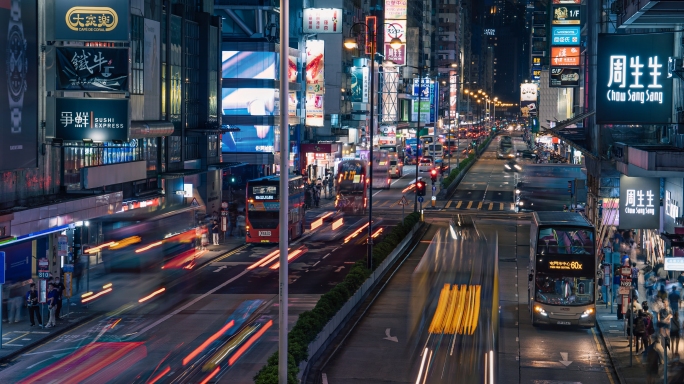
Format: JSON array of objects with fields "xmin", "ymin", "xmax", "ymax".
[{"xmin": 0, "ymin": 0, "xmax": 38, "ymax": 171}]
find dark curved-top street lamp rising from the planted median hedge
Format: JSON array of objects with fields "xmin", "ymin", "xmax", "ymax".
[{"xmin": 344, "ymin": 23, "xmax": 380, "ymax": 270}]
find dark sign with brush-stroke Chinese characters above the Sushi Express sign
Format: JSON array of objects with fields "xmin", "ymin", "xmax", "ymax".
[{"xmin": 57, "ymin": 47, "xmax": 128, "ymax": 91}]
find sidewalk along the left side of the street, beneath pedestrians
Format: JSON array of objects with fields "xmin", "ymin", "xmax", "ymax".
[{"xmin": 0, "ymin": 237, "xmax": 245, "ymax": 364}]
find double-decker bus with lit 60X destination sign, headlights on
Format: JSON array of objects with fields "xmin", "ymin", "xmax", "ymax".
[{"xmin": 527, "ymin": 212, "xmax": 596, "ymax": 327}]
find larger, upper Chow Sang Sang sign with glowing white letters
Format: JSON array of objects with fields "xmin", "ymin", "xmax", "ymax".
[{"xmin": 596, "ymin": 33, "xmax": 675, "ymax": 124}]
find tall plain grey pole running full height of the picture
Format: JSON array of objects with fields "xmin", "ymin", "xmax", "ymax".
[{"xmin": 278, "ymin": 0, "xmax": 290, "ymax": 384}]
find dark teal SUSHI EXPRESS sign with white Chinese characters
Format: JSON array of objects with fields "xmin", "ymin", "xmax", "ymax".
[{"xmin": 55, "ymin": 98, "xmax": 129, "ymax": 142}]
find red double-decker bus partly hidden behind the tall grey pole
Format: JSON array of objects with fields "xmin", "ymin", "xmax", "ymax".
[{"xmin": 245, "ymin": 176, "xmax": 304, "ymax": 243}]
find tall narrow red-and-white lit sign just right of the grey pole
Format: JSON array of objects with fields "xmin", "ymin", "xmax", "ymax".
[{"xmin": 305, "ymin": 40, "xmax": 325, "ymax": 127}]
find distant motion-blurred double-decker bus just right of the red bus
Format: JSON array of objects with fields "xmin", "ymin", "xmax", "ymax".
[{"xmin": 335, "ymin": 160, "xmax": 368, "ymax": 214}]
